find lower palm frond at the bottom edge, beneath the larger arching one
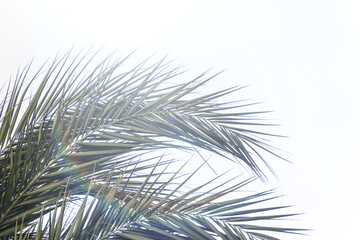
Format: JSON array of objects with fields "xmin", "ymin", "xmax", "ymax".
[{"xmin": 12, "ymin": 158, "xmax": 301, "ymax": 240}]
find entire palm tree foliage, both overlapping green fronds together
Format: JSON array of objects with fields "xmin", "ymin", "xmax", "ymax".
[{"xmin": 0, "ymin": 50, "xmax": 299, "ymax": 239}]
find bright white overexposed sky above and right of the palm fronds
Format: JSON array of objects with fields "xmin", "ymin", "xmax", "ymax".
[{"xmin": 0, "ymin": 0, "xmax": 360, "ymax": 240}]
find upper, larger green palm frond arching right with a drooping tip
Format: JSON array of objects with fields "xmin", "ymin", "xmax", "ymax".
[{"xmin": 0, "ymin": 53, "xmax": 300, "ymax": 238}]
